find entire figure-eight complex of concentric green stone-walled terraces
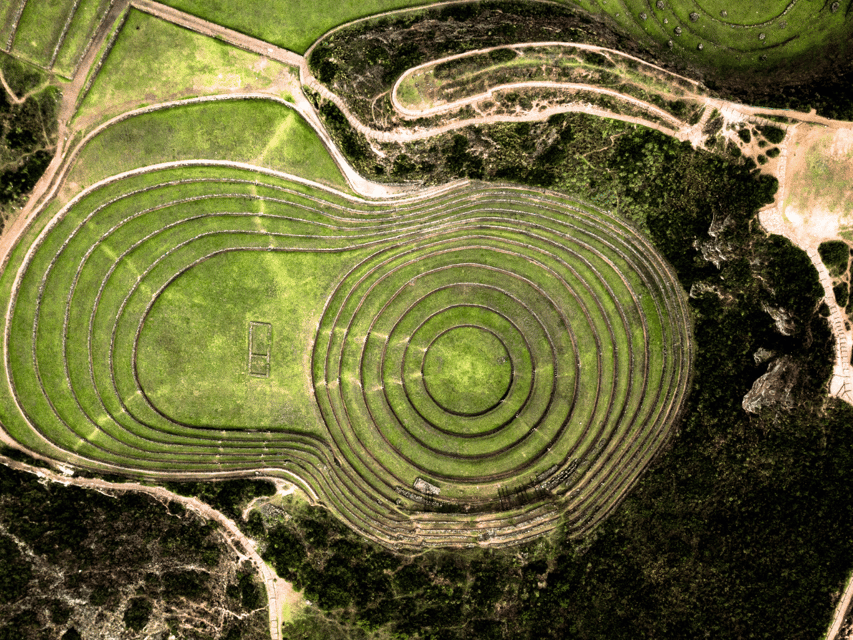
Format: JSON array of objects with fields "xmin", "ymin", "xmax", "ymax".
[{"xmin": 4, "ymin": 164, "xmax": 692, "ymax": 548}]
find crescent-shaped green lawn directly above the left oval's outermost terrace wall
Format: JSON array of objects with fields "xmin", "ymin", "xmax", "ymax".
[{"xmin": 63, "ymin": 100, "xmax": 347, "ymax": 199}]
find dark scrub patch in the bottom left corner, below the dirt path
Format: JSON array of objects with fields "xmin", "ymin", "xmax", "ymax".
[{"xmin": 0, "ymin": 458, "xmax": 269, "ymax": 640}]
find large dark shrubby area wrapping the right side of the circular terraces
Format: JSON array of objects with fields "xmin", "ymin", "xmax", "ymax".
[{"xmin": 255, "ymin": 104, "xmax": 853, "ymax": 640}]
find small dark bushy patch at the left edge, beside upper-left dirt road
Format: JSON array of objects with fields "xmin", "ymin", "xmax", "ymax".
[{"xmin": 0, "ymin": 53, "xmax": 59, "ymax": 230}]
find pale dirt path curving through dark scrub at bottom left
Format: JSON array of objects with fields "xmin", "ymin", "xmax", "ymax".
[{"xmin": 0, "ymin": 456, "xmax": 300, "ymax": 640}]
